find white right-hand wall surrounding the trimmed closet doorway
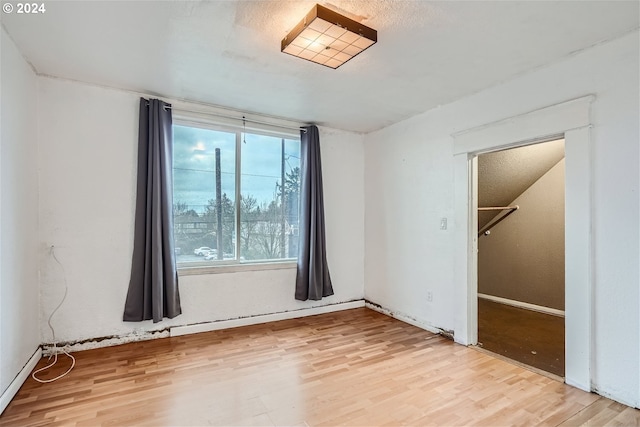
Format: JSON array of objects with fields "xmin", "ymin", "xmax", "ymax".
[{"xmin": 365, "ymin": 31, "xmax": 640, "ymax": 406}]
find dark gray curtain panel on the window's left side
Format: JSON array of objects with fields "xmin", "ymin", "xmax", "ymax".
[{"xmin": 123, "ymin": 98, "xmax": 182, "ymax": 323}]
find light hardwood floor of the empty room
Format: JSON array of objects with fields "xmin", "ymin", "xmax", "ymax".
[{"xmin": 0, "ymin": 308, "xmax": 640, "ymax": 426}]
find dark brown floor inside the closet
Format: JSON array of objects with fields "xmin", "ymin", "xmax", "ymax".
[{"xmin": 478, "ymin": 298, "xmax": 564, "ymax": 377}]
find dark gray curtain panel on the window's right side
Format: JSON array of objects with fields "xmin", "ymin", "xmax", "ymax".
[{"xmin": 295, "ymin": 126, "xmax": 333, "ymax": 301}]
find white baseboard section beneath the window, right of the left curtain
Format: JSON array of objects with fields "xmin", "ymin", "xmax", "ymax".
[{"xmin": 170, "ymin": 300, "xmax": 365, "ymax": 337}]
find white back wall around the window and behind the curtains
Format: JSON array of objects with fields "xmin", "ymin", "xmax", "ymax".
[{"xmin": 39, "ymin": 77, "xmax": 364, "ymax": 342}]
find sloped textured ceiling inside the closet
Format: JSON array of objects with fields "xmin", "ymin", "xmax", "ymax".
[{"xmin": 478, "ymin": 139, "xmax": 564, "ymax": 229}]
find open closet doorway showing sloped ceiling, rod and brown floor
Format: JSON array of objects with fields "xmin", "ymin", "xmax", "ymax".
[{"xmin": 477, "ymin": 139, "xmax": 565, "ymax": 377}]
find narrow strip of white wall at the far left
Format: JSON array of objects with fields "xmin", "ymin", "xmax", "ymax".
[{"xmin": 0, "ymin": 29, "xmax": 40, "ymax": 392}]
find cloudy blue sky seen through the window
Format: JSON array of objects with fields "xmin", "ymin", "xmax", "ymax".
[{"xmin": 173, "ymin": 125, "xmax": 300, "ymax": 212}]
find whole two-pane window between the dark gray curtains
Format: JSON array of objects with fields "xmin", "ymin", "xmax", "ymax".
[{"xmin": 173, "ymin": 122, "xmax": 300, "ymax": 267}]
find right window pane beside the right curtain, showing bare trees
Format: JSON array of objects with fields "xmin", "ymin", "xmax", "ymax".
[{"xmin": 240, "ymin": 134, "xmax": 300, "ymax": 260}]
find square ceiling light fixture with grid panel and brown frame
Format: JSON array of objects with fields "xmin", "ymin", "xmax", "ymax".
[{"xmin": 280, "ymin": 4, "xmax": 378, "ymax": 69}]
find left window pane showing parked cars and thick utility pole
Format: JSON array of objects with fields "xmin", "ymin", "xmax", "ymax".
[{"xmin": 173, "ymin": 125, "xmax": 236, "ymax": 262}]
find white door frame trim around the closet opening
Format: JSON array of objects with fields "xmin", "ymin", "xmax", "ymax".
[{"xmin": 452, "ymin": 95, "xmax": 595, "ymax": 391}]
